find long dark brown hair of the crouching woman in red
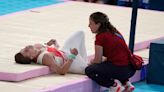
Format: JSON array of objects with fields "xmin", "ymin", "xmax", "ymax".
[{"xmin": 90, "ymin": 12, "xmax": 118, "ymax": 34}]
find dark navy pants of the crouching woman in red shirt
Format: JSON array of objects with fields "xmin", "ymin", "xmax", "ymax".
[{"xmin": 85, "ymin": 61, "xmax": 135, "ymax": 87}]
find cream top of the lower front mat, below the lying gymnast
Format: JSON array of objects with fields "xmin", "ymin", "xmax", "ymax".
[{"xmin": 0, "ymin": 74, "xmax": 86, "ymax": 92}]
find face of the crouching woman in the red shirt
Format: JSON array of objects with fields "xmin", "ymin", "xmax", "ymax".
[{"xmin": 88, "ymin": 18, "xmax": 100, "ymax": 33}]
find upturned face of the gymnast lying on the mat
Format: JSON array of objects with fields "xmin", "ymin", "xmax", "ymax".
[{"xmin": 20, "ymin": 45, "xmax": 37, "ymax": 59}]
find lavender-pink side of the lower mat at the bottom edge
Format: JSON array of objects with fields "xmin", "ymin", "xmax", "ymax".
[{"xmin": 36, "ymin": 77, "xmax": 100, "ymax": 92}]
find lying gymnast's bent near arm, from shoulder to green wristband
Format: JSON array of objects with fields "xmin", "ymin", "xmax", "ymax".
[{"xmin": 43, "ymin": 53, "xmax": 73, "ymax": 75}]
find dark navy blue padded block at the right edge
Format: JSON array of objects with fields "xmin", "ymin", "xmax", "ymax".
[{"xmin": 147, "ymin": 39, "xmax": 164, "ymax": 85}]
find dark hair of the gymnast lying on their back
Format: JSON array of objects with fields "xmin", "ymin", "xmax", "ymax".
[{"xmin": 15, "ymin": 52, "xmax": 32, "ymax": 64}]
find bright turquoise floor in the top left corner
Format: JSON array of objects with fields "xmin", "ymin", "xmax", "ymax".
[{"xmin": 0, "ymin": 0, "xmax": 62, "ymax": 16}]
